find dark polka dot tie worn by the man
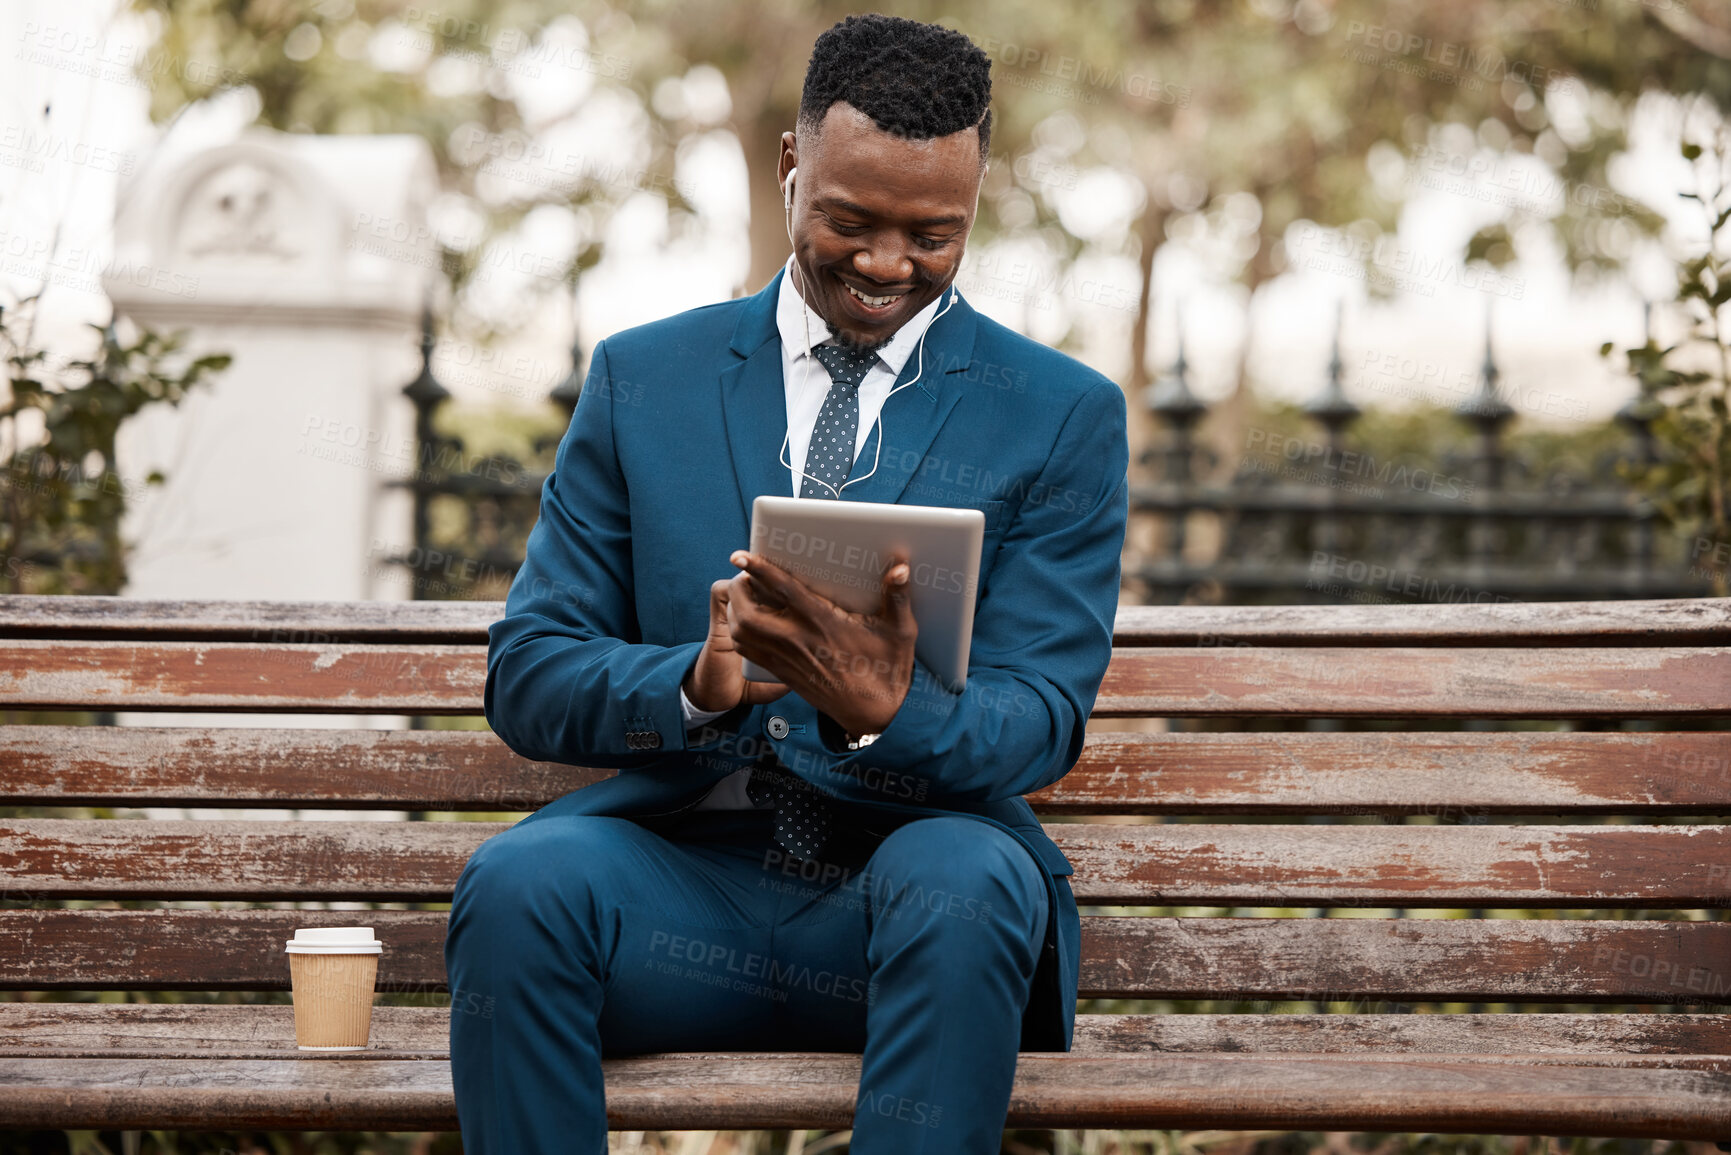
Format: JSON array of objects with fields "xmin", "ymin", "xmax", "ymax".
[{"xmin": 746, "ymin": 334, "xmax": 878, "ymax": 861}]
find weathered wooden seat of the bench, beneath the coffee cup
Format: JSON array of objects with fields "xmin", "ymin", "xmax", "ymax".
[{"xmin": 0, "ymin": 1004, "xmax": 1731, "ymax": 1138}]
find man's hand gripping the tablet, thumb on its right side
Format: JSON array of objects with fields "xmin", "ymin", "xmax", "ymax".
[{"xmin": 720, "ymin": 549, "xmax": 919, "ymax": 734}]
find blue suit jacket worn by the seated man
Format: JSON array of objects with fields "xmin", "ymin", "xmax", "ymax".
[{"xmin": 486, "ymin": 274, "xmax": 1129, "ymax": 1051}]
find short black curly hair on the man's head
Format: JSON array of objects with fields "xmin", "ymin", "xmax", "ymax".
[{"xmin": 798, "ymin": 12, "xmax": 992, "ymax": 165}]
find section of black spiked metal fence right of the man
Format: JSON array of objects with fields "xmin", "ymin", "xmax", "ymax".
[{"xmin": 1125, "ymin": 316, "xmax": 1712, "ymax": 604}]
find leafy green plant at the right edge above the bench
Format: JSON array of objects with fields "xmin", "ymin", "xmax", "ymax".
[{"xmin": 1599, "ymin": 115, "xmax": 1731, "ymax": 594}]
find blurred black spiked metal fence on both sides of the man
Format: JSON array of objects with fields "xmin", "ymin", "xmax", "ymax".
[{"xmin": 391, "ymin": 312, "xmax": 1714, "ymax": 604}]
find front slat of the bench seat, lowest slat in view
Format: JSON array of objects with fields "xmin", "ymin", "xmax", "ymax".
[{"xmin": 0, "ymin": 1053, "xmax": 1731, "ymax": 1139}]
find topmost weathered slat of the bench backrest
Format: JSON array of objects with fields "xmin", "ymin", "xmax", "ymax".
[{"xmin": 0, "ymin": 596, "xmax": 1731, "ymax": 646}]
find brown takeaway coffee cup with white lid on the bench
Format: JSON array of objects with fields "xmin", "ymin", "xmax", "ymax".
[{"xmin": 287, "ymin": 926, "xmax": 384, "ymax": 1051}]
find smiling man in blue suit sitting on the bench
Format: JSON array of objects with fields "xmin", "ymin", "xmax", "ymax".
[{"xmin": 445, "ymin": 16, "xmax": 1129, "ymax": 1155}]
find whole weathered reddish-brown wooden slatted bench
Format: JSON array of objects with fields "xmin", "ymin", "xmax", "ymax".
[{"xmin": 0, "ymin": 597, "xmax": 1731, "ymax": 1139}]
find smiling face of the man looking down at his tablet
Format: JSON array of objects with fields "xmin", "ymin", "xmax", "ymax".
[{"xmin": 781, "ymin": 100, "xmax": 981, "ymax": 348}]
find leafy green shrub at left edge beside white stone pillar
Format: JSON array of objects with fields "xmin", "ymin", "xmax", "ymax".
[{"xmin": 0, "ymin": 296, "xmax": 230, "ymax": 594}]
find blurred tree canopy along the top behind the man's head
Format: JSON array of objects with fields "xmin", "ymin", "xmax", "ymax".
[{"xmin": 118, "ymin": 0, "xmax": 1731, "ymax": 380}]
